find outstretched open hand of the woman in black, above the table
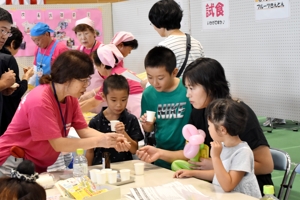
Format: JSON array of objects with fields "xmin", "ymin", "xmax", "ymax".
[{"xmin": 136, "ymin": 145, "xmax": 160, "ymax": 163}]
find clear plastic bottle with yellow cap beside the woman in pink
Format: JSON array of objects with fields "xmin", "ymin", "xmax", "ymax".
[{"xmin": 73, "ymin": 149, "xmax": 88, "ymax": 177}]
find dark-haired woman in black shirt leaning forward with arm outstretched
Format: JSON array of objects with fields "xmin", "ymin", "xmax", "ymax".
[{"xmin": 137, "ymin": 58, "xmax": 274, "ymax": 195}]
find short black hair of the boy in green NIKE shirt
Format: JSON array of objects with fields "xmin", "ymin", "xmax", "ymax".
[{"xmin": 144, "ymin": 46, "xmax": 176, "ymax": 74}]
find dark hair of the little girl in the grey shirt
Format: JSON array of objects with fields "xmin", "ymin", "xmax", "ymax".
[{"xmin": 205, "ymin": 98, "xmax": 247, "ymax": 136}]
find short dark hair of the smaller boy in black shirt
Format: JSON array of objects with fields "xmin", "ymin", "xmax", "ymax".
[{"xmin": 103, "ymin": 74, "xmax": 129, "ymax": 96}]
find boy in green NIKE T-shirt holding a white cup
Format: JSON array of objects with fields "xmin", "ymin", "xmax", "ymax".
[{"xmin": 137, "ymin": 46, "xmax": 192, "ymax": 169}]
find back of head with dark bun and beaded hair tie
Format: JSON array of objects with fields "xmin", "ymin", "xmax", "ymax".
[{"xmin": 0, "ymin": 160, "xmax": 46, "ymax": 200}]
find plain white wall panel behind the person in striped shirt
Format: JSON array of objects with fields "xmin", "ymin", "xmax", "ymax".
[{"xmin": 112, "ymin": 0, "xmax": 190, "ymax": 73}]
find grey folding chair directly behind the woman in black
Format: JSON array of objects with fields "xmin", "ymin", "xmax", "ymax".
[{"xmin": 270, "ymin": 148, "xmax": 291, "ymax": 199}]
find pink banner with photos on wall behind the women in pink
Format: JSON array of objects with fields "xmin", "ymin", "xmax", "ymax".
[{"xmin": 10, "ymin": 9, "xmax": 103, "ymax": 56}]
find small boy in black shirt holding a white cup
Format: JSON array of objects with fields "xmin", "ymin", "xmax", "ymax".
[{"xmin": 86, "ymin": 75, "xmax": 144, "ymax": 165}]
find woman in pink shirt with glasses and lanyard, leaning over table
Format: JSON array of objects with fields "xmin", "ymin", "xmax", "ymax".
[{"xmin": 0, "ymin": 50, "xmax": 130, "ymax": 176}]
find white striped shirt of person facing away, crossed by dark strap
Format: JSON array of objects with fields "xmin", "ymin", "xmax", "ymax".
[{"xmin": 158, "ymin": 35, "xmax": 204, "ymax": 76}]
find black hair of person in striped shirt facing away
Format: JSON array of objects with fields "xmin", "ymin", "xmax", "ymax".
[{"xmin": 148, "ymin": 0, "xmax": 183, "ymax": 30}]
